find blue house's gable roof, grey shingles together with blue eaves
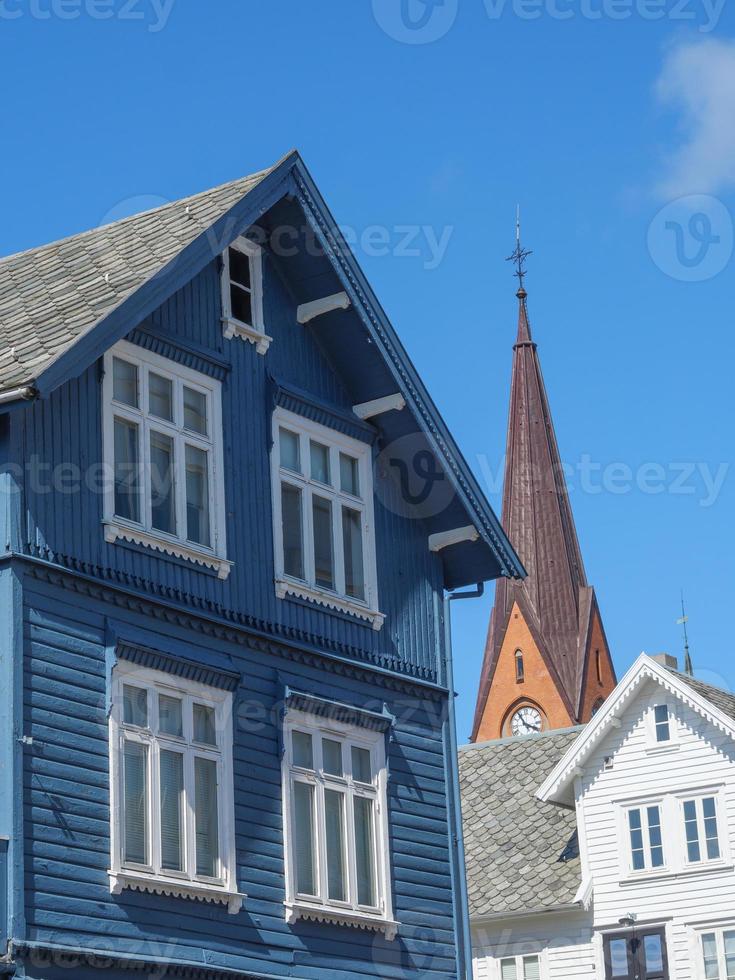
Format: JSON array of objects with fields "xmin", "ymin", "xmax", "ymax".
[{"xmin": 0, "ymin": 151, "xmax": 524, "ymax": 589}]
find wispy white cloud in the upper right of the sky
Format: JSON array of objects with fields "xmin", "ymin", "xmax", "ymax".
[{"xmin": 656, "ymin": 39, "xmax": 735, "ymax": 198}]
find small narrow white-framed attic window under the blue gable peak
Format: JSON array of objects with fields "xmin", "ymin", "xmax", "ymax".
[{"xmin": 222, "ymin": 238, "xmax": 271, "ymax": 354}]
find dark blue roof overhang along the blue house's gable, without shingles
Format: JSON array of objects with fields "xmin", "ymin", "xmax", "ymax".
[{"xmin": 2, "ymin": 151, "xmax": 525, "ymax": 589}]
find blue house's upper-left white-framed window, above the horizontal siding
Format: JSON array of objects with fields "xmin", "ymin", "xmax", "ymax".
[{"xmin": 103, "ymin": 342, "xmax": 230, "ymax": 578}]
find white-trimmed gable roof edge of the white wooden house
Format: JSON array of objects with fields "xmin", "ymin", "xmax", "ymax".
[{"xmin": 538, "ymin": 653, "xmax": 735, "ymax": 806}]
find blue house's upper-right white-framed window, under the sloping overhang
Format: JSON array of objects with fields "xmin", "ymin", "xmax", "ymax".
[{"xmin": 273, "ymin": 409, "xmax": 384, "ymax": 629}]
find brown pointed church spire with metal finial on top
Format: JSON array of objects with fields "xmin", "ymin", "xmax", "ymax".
[{"xmin": 472, "ymin": 238, "xmax": 614, "ymax": 740}]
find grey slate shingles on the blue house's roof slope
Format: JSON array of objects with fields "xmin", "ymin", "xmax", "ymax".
[{"xmin": 0, "ymin": 164, "xmax": 278, "ymax": 391}]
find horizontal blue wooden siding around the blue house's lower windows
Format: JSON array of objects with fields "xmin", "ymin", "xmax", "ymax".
[{"xmin": 23, "ymin": 567, "xmax": 455, "ymax": 980}]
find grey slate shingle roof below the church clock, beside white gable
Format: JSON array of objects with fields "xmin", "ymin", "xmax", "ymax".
[{"xmin": 459, "ymin": 728, "xmax": 582, "ymax": 916}]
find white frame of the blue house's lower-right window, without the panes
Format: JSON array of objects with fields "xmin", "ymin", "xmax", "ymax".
[{"xmin": 282, "ymin": 709, "xmax": 399, "ymax": 940}]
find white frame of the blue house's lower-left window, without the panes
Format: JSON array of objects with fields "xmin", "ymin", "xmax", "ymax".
[{"xmin": 108, "ymin": 660, "xmax": 240, "ymax": 915}]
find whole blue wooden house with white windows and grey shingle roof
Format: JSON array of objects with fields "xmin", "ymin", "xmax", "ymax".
[{"xmin": 0, "ymin": 153, "xmax": 523, "ymax": 980}]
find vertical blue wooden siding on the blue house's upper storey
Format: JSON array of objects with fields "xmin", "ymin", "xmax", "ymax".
[{"xmin": 14, "ymin": 257, "xmax": 442, "ymax": 679}]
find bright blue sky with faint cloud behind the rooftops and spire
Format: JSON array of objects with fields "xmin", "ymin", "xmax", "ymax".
[{"xmin": 0, "ymin": 0, "xmax": 735, "ymax": 740}]
